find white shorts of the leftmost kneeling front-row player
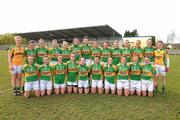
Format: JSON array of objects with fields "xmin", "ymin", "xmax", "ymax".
[{"xmin": 24, "ymin": 81, "xmax": 39, "ymax": 91}]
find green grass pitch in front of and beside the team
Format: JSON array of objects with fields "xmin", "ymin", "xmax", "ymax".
[{"xmin": 0, "ymin": 51, "xmax": 180, "ymax": 120}]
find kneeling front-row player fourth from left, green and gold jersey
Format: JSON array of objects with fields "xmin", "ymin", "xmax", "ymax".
[{"xmin": 67, "ymin": 54, "xmax": 78, "ymax": 93}]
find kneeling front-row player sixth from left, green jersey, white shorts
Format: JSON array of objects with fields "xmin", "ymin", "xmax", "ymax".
[{"xmin": 89, "ymin": 57, "xmax": 103, "ymax": 94}]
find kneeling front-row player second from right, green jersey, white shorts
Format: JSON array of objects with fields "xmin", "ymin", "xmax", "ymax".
[{"xmin": 130, "ymin": 56, "xmax": 142, "ymax": 96}]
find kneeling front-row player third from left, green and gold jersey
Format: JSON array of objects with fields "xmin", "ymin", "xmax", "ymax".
[{"xmin": 53, "ymin": 56, "xmax": 67, "ymax": 95}]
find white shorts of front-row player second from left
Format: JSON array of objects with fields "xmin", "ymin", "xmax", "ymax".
[{"xmin": 40, "ymin": 80, "xmax": 52, "ymax": 90}]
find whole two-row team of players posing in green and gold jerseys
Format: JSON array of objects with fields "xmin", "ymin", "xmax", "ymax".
[{"xmin": 8, "ymin": 36, "xmax": 170, "ymax": 98}]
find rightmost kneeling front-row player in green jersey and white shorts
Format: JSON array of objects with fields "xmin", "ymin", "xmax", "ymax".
[{"xmin": 141, "ymin": 57, "xmax": 155, "ymax": 97}]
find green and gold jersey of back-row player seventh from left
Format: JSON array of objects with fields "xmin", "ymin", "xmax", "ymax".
[{"xmin": 81, "ymin": 44, "xmax": 91, "ymax": 59}]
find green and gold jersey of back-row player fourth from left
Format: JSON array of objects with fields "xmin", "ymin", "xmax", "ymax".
[{"xmin": 49, "ymin": 47, "xmax": 61, "ymax": 61}]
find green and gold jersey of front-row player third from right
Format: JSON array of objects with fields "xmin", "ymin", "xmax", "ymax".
[{"xmin": 117, "ymin": 63, "xmax": 130, "ymax": 80}]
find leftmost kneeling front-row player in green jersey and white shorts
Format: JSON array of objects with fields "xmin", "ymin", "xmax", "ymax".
[{"xmin": 22, "ymin": 56, "xmax": 40, "ymax": 98}]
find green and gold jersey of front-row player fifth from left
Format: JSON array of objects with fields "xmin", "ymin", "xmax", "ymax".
[{"xmin": 77, "ymin": 65, "xmax": 89, "ymax": 80}]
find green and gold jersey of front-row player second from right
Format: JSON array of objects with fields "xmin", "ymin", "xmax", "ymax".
[{"xmin": 130, "ymin": 63, "xmax": 142, "ymax": 80}]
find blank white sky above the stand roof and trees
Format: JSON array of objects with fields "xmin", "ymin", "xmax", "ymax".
[{"xmin": 0, "ymin": 0, "xmax": 180, "ymax": 41}]
